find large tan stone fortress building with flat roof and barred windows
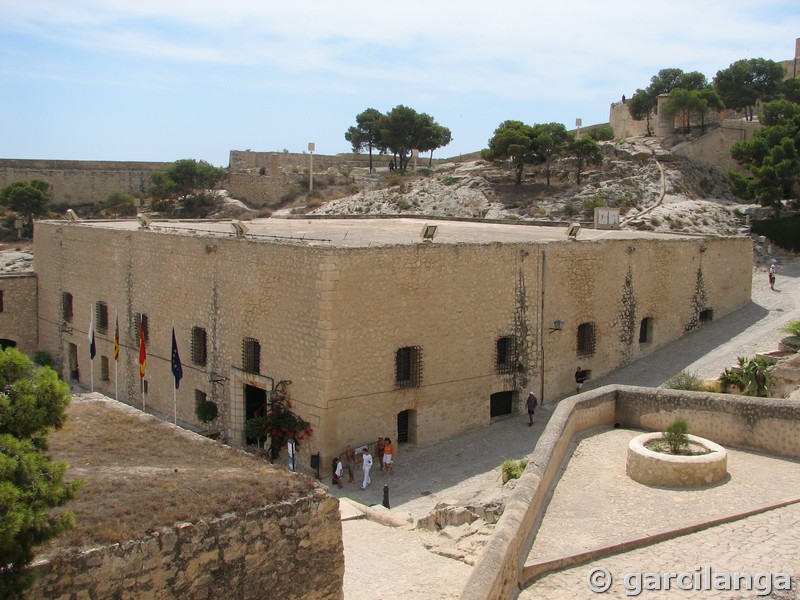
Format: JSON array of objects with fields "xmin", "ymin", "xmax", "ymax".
[{"xmin": 26, "ymin": 218, "xmax": 752, "ymax": 468}]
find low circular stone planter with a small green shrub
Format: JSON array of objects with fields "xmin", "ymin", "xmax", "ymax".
[{"xmin": 626, "ymin": 432, "xmax": 728, "ymax": 487}]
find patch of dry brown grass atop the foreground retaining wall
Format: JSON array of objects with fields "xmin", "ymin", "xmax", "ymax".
[{"xmin": 42, "ymin": 399, "xmax": 315, "ymax": 553}]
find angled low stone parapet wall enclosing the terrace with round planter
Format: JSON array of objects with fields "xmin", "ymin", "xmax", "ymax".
[{"xmin": 461, "ymin": 386, "xmax": 800, "ymax": 600}]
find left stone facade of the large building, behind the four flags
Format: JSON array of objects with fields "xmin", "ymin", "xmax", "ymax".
[{"xmin": 34, "ymin": 221, "xmax": 325, "ymax": 460}]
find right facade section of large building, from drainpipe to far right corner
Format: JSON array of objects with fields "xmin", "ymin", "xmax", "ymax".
[{"xmin": 539, "ymin": 238, "xmax": 752, "ymax": 402}]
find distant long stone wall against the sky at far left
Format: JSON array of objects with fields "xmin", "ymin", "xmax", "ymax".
[{"xmin": 0, "ymin": 159, "xmax": 172, "ymax": 206}]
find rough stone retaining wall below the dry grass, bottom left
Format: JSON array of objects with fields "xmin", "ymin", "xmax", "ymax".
[{"xmin": 26, "ymin": 487, "xmax": 344, "ymax": 600}]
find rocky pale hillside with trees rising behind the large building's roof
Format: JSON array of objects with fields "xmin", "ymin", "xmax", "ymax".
[{"xmin": 302, "ymin": 138, "xmax": 760, "ymax": 235}]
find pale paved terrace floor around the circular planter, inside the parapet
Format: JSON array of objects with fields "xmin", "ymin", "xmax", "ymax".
[{"xmin": 520, "ymin": 429, "xmax": 800, "ymax": 598}]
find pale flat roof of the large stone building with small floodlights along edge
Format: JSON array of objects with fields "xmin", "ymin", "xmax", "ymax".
[{"xmin": 39, "ymin": 217, "xmax": 708, "ymax": 247}]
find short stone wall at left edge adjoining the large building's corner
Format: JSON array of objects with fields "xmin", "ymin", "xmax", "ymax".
[{"xmin": 0, "ymin": 273, "xmax": 39, "ymax": 355}]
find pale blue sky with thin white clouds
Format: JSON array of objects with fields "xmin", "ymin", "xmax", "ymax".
[{"xmin": 0, "ymin": 0, "xmax": 800, "ymax": 167}]
